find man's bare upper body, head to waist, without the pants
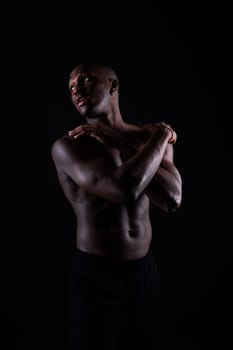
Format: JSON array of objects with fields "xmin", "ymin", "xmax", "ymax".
[{"xmin": 51, "ymin": 65, "xmax": 182, "ymax": 260}]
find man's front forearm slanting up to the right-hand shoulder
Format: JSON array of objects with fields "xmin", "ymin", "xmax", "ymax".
[{"xmin": 115, "ymin": 128, "xmax": 170, "ymax": 198}]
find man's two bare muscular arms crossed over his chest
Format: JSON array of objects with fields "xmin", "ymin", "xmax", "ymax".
[{"xmin": 52, "ymin": 121, "xmax": 181, "ymax": 212}]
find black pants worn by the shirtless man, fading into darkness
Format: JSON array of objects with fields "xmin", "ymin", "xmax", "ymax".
[{"xmin": 68, "ymin": 250, "xmax": 160, "ymax": 350}]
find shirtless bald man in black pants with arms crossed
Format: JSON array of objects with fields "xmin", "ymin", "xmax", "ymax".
[{"xmin": 51, "ymin": 64, "xmax": 182, "ymax": 350}]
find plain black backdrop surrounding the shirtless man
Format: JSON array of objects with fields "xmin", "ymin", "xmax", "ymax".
[{"xmin": 0, "ymin": 10, "xmax": 229, "ymax": 350}]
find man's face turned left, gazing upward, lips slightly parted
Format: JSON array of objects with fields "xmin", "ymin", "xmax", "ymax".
[{"xmin": 69, "ymin": 66, "xmax": 110, "ymax": 117}]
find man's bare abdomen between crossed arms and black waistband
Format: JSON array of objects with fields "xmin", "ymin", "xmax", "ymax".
[{"xmin": 73, "ymin": 195, "xmax": 152, "ymax": 259}]
